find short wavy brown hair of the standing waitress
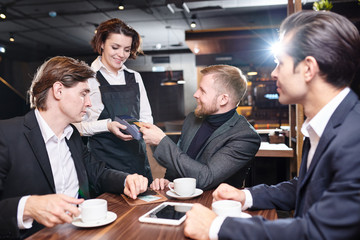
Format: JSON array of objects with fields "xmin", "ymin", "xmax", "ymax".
[{"xmin": 91, "ymin": 18, "xmax": 142, "ymax": 59}]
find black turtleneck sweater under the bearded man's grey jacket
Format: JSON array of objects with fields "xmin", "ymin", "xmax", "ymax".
[{"xmin": 186, "ymin": 108, "xmax": 236, "ymax": 159}]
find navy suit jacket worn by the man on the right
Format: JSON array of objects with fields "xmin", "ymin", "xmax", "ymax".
[{"xmin": 219, "ymin": 91, "xmax": 360, "ymax": 240}]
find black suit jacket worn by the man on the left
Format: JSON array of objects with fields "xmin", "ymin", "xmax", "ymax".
[{"xmin": 0, "ymin": 110, "xmax": 127, "ymax": 239}]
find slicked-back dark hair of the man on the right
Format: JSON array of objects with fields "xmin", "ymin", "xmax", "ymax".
[{"xmin": 280, "ymin": 11, "xmax": 360, "ymax": 88}]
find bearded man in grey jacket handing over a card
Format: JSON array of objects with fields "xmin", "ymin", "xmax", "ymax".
[{"xmin": 140, "ymin": 65, "xmax": 261, "ymax": 190}]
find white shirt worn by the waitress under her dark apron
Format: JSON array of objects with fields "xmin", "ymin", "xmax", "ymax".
[{"xmin": 74, "ymin": 56, "xmax": 153, "ymax": 136}]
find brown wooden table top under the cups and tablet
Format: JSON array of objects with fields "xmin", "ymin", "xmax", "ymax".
[{"xmin": 27, "ymin": 191, "xmax": 277, "ymax": 240}]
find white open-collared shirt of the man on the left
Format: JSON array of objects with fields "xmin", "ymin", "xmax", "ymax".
[{"xmin": 17, "ymin": 109, "xmax": 79, "ymax": 229}]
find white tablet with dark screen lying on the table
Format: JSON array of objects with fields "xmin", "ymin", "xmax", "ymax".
[{"xmin": 139, "ymin": 202, "xmax": 193, "ymax": 225}]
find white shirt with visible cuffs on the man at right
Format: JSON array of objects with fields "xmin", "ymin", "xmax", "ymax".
[{"xmin": 209, "ymin": 87, "xmax": 350, "ymax": 240}]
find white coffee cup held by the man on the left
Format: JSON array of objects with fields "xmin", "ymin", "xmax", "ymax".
[{"xmin": 79, "ymin": 199, "xmax": 107, "ymax": 223}]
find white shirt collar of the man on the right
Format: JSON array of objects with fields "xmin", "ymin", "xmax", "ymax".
[{"xmin": 301, "ymin": 87, "xmax": 350, "ymax": 138}]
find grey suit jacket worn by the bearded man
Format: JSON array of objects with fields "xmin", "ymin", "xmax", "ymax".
[{"xmin": 154, "ymin": 113, "xmax": 260, "ymax": 190}]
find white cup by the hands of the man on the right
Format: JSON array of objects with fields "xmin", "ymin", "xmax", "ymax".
[{"xmin": 211, "ymin": 200, "xmax": 241, "ymax": 217}]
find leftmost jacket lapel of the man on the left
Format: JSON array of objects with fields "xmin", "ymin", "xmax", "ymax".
[{"xmin": 24, "ymin": 111, "xmax": 56, "ymax": 193}]
